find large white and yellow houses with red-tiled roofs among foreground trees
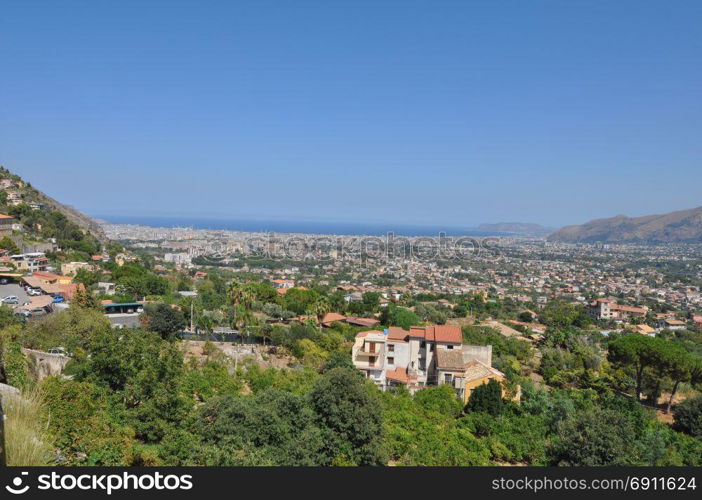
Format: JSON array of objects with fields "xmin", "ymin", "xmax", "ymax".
[{"xmin": 351, "ymin": 325, "xmax": 518, "ymax": 402}]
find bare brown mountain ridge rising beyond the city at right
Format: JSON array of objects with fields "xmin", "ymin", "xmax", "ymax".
[{"xmin": 548, "ymin": 207, "xmax": 702, "ymax": 243}]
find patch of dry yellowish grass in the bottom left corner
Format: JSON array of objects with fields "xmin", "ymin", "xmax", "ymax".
[{"xmin": 2, "ymin": 391, "xmax": 51, "ymax": 466}]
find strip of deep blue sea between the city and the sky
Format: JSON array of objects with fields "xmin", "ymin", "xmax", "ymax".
[{"xmin": 96, "ymin": 215, "xmax": 509, "ymax": 237}]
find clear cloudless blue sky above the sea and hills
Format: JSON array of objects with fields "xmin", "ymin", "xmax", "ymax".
[{"xmin": 0, "ymin": 0, "xmax": 702, "ymax": 226}]
